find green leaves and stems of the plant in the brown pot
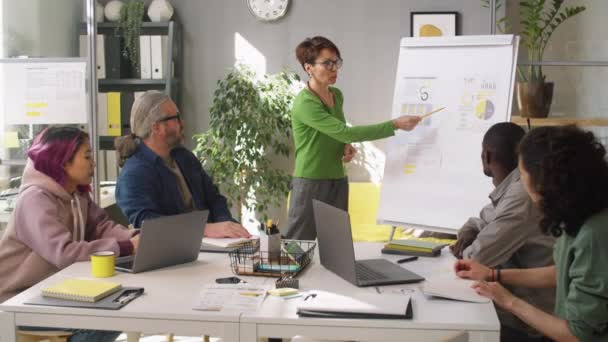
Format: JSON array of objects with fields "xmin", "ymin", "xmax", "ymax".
[{"xmin": 481, "ymin": 0, "xmax": 586, "ymax": 82}]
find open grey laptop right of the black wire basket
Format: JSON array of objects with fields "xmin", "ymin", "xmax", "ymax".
[{"xmin": 312, "ymin": 200, "xmax": 424, "ymax": 286}]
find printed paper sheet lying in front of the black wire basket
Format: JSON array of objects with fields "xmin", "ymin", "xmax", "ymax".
[{"xmin": 192, "ymin": 284, "xmax": 267, "ymax": 312}]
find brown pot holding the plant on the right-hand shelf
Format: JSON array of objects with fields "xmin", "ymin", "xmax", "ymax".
[{"xmin": 517, "ymin": 82, "xmax": 554, "ymax": 118}]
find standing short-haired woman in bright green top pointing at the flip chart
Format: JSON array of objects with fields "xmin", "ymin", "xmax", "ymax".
[{"xmin": 286, "ymin": 37, "xmax": 420, "ymax": 240}]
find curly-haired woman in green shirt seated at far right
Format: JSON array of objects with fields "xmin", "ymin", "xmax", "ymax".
[{"xmin": 454, "ymin": 126, "xmax": 608, "ymax": 341}]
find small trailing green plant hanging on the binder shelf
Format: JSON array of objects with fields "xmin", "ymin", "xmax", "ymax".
[{"xmin": 117, "ymin": 0, "xmax": 145, "ymax": 71}]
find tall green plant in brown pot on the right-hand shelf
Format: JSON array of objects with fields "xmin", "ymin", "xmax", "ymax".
[{"xmin": 482, "ymin": 0, "xmax": 585, "ymax": 117}]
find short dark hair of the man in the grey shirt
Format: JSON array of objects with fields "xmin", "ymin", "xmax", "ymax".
[{"xmin": 483, "ymin": 122, "xmax": 526, "ymax": 171}]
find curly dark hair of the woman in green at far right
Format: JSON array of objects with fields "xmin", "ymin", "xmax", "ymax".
[{"xmin": 519, "ymin": 126, "xmax": 608, "ymax": 237}]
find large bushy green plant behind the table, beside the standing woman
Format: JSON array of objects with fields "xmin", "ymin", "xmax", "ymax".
[{"xmin": 194, "ymin": 65, "xmax": 302, "ymax": 220}]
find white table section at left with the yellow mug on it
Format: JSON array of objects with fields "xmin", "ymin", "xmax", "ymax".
[{"xmin": 0, "ymin": 254, "xmax": 247, "ymax": 342}]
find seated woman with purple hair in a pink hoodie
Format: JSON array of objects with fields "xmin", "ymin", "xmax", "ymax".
[{"xmin": 0, "ymin": 127, "xmax": 139, "ymax": 342}]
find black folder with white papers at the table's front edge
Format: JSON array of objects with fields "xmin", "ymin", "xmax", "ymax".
[{"xmin": 297, "ymin": 291, "xmax": 413, "ymax": 319}]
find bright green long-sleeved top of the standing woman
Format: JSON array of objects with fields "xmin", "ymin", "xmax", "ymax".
[{"xmin": 291, "ymin": 87, "xmax": 395, "ymax": 179}]
